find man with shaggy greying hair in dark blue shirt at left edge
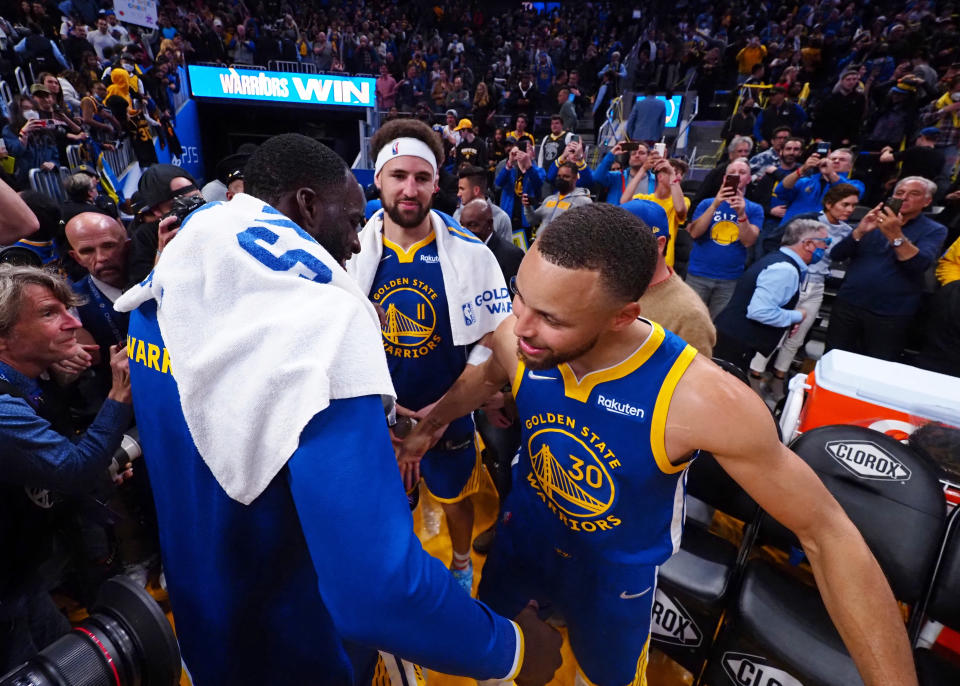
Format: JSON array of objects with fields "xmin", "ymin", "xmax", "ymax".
[{"xmin": 0, "ymin": 265, "xmax": 133, "ymax": 672}]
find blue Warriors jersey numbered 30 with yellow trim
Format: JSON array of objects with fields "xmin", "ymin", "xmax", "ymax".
[{"xmin": 505, "ymin": 323, "xmax": 696, "ymax": 564}]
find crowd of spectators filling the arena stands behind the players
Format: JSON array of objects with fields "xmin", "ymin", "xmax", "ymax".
[{"xmin": 0, "ymin": 0, "xmax": 960, "ymax": 671}]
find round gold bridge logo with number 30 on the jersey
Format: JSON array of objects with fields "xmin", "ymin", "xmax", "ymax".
[{"xmin": 527, "ymin": 428, "xmax": 616, "ymax": 520}]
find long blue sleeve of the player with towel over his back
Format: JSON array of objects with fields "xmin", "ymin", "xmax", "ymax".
[{"xmin": 287, "ymin": 396, "xmax": 518, "ymax": 679}]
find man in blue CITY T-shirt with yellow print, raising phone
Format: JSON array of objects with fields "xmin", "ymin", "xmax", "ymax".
[{"xmin": 687, "ymin": 159, "xmax": 763, "ymax": 319}]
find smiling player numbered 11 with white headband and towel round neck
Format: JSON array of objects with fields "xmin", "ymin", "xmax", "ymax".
[{"xmin": 347, "ymin": 119, "xmax": 510, "ymax": 593}]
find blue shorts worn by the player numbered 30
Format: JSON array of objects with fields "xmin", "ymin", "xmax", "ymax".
[{"xmin": 477, "ymin": 502, "xmax": 657, "ymax": 686}]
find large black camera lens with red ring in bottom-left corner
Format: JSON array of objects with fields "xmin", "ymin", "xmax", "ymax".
[{"xmin": 0, "ymin": 576, "xmax": 181, "ymax": 686}]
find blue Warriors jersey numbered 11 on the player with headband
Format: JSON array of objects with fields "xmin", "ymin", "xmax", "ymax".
[{"xmin": 370, "ymin": 232, "xmax": 467, "ymax": 410}]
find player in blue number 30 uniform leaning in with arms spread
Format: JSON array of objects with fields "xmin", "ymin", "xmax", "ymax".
[{"xmin": 400, "ymin": 206, "xmax": 917, "ymax": 686}]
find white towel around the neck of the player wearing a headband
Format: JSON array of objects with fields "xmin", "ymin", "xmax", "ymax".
[{"xmin": 347, "ymin": 210, "xmax": 512, "ymax": 345}]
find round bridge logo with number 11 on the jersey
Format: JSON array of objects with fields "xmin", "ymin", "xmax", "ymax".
[{"xmin": 372, "ymin": 278, "xmax": 440, "ymax": 358}]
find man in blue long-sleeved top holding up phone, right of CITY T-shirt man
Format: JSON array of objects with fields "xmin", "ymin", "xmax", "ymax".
[{"xmin": 770, "ymin": 143, "xmax": 864, "ymax": 226}]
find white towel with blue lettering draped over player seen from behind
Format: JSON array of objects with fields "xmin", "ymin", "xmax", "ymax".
[{"xmin": 116, "ymin": 194, "xmax": 395, "ymax": 504}]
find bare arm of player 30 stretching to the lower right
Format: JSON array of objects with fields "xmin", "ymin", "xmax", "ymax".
[{"xmin": 666, "ymin": 357, "xmax": 917, "ymax": 686}]
